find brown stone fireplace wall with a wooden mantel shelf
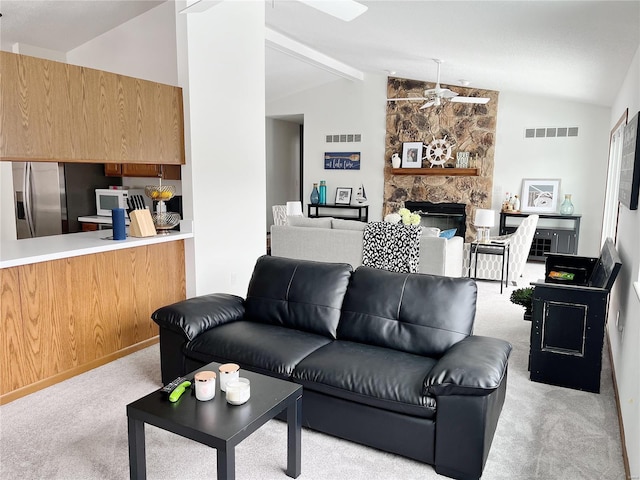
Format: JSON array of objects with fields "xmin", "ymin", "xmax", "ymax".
[{"xmin": 383, "ymin": 77, "xmax": 498, "ymax": 241}]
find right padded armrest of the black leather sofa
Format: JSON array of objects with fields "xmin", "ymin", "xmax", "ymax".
[{"xmin": 423, "ymin": 335, "xmax": 511, "ymax": 396}]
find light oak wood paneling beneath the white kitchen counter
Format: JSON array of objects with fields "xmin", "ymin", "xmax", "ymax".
[{"xmin": 0, "ymin": 241, "xmax": 186, "ymax": 403}]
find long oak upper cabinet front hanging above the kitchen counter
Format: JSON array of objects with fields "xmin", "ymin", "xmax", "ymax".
[{"xmin": 0, "ymin": 52, "xmax": 184, "ymax": 165}]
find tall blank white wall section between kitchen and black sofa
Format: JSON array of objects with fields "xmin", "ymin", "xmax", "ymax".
[{"xmin": 179, "ymin": 2, "xmax": 266, "ymax": 296}]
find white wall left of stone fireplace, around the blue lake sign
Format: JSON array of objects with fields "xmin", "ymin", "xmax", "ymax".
[{"xmin": 267, "ymin": 75, "xmax": 389, "ymax": 220}]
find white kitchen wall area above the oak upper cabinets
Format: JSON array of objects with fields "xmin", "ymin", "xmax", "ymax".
[{"xmin": 67, "ymin": 2, "xmax": 178, "ymax": 85}]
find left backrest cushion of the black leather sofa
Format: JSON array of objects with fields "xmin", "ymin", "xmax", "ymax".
[{"xmin": 244, "ymin": 255, "xmax": 352, "ymax": 339}]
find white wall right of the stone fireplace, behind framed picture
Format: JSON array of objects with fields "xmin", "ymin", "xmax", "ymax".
[{"xmin": 492, "ymin": 92, "xmax": 611, "ymax": 256}]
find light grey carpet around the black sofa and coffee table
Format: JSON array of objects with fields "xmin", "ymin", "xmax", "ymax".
[{"xmin": 0, "ymin": 264, "xmax": 624, "ymax": 480}]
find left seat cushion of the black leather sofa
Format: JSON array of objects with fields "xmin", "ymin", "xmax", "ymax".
[{"xmin": 184, "ymin": 320, "xmax": 331, "ymax": 379}]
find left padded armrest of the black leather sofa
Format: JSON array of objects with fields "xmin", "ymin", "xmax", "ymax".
[{"xmin": 151, "ymin": 293, "xmax": 244, "ymax": 340}]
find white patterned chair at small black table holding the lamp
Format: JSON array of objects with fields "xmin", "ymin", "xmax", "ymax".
[{"xmin": 463, "ymin": 215, "xmax": 539, "ymax": 285}]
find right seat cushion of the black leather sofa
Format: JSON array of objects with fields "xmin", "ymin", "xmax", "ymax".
[{"xmin": 292, "ymin": 340, "xmax": 436, "ymax": 418}]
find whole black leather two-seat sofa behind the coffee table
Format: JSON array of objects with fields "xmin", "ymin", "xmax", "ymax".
[{"xmin": 152, "ymin": 256, "xmax": 511, "ymax": 479}]
